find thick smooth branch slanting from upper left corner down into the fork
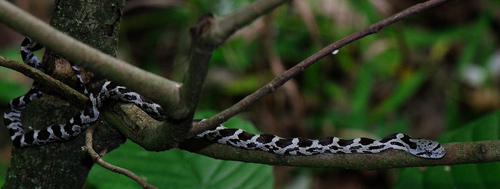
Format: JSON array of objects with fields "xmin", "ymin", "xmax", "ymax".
[{"xmin": 0, "ymin": 1, "xmax": 192, "ymax": 151}]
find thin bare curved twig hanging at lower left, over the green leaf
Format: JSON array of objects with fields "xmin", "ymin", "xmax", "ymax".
[{"xmin": 85, "ymin": 125, "xmax": 156, "ymax": 188}]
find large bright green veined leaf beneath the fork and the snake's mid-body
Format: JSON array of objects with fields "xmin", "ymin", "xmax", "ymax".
[{"xmin": 88, "ymin": 116, "xmax": 273, "ymax": 188}]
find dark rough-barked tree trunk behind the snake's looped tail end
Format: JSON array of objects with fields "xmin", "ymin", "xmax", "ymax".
[{"xmin": 4, "ymin": 0, "xmax": 125, "ymax": 188}]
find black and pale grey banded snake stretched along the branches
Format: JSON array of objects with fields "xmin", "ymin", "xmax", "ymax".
[{"xmin": 0, "ymin": 37, "xmax": 446, "ymax": 159}]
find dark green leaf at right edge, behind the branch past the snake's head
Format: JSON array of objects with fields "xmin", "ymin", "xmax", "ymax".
[{"xmin": 396, "ymin": 111, "xmax": 500, "ymax": 188}]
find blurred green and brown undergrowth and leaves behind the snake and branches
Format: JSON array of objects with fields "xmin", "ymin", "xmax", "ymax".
[{"xmin": 0, "ymin": 0, "xmax": 500, "ymax": 188}]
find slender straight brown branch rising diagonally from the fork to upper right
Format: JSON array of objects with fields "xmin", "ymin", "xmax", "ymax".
[{"xmin": 192, "ymin": 0, "xmax": 449, "ymax": 136}]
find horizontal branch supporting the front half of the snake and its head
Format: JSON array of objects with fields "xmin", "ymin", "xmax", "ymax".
[{"xmin": 181, "ymin": 139, "xmax": 500, "ymax": 170}]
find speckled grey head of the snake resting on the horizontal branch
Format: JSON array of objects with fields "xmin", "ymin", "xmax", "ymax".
[{"xmin": 410, "ymin": 139, "xmax": 446, "ymax": 159}]
